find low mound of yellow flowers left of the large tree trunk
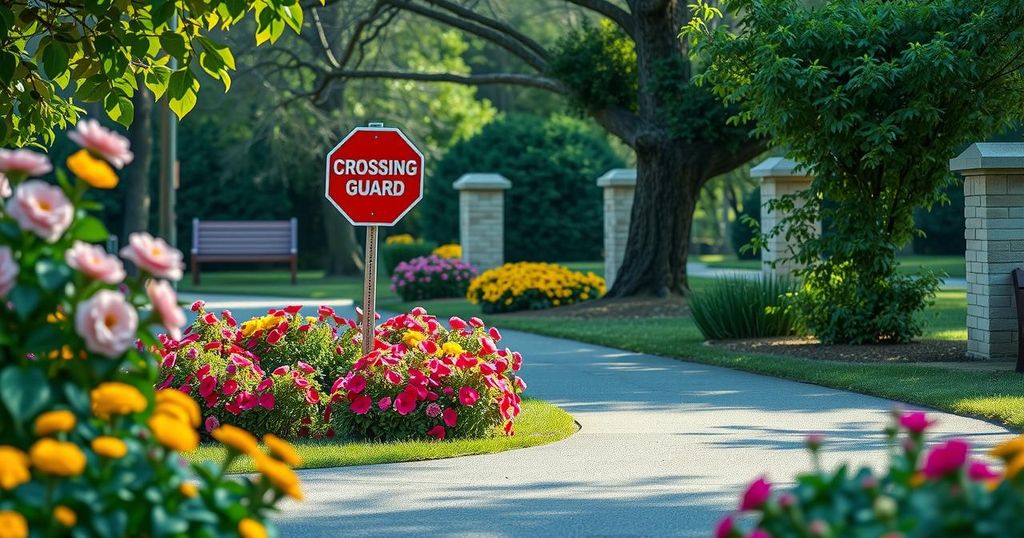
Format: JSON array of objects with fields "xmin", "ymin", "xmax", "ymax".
[{"xmin": 466, "ymin": 261, "xmax": 605, "ymax": 314}]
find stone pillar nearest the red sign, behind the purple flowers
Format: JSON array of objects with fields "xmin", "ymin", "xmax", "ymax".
[{"xmin": 452, "ymin": 174, "xmax": 512, "ymax": 271}]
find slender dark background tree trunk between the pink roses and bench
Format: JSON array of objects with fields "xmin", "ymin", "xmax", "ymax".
[{"xmin": 121, "ymin": 84, "xmax": 153, "ymax": 238}]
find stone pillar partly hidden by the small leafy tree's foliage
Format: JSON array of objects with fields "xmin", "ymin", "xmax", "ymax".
[{"xmin": 736, "ymin": 157, "xmax": 821, "ymax": 277}]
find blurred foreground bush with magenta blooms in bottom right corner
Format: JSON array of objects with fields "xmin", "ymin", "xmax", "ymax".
[{"xmin": 715, "ymin": 412, "xmax": 1024, "ymax": 538}]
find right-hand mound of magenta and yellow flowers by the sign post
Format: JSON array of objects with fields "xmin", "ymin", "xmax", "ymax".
[{"xmin": 331, "ymin": 308, "xmax": 526, "ymax": 441}]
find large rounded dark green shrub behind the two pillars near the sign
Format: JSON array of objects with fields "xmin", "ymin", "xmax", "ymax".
[{"xmin": 418, "ymin": 116, "xmax": 625, "ymax": 261}]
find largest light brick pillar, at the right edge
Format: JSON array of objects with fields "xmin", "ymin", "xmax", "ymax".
[{"xmin": 949, "ymin": 143, "xmax": 1024, "ymax": 359}]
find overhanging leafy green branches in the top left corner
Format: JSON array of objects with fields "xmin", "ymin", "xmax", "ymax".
[{"xmin": 0, "ymin": 0, "xmax": 311, "ymax": 146}]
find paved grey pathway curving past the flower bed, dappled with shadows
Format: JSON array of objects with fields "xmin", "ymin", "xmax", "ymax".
[{"xmin": 184, "ymin": 300, "xmax": 1011, "ymax": 538}]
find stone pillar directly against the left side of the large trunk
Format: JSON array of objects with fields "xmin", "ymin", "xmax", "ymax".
[{"xmin": 597, "ymin": 168, "xmax": 637, "ymax": 289}]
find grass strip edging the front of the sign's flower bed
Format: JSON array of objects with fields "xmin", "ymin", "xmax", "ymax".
[{"xmin": 186, "ymin": 399, "xmax": 575, "ymax": 472}]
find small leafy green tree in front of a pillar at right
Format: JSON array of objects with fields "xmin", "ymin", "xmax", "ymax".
[{"xmin": 686, "ymin": 0, "xmax": 1024, "ymax": 343}]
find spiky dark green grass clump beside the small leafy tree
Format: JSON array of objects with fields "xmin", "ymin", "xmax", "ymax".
[{"xmin": 689, "ymin": 276, "xmax": 799, "ymax": 340}]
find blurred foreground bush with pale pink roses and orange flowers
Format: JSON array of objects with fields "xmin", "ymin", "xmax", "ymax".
[{"xmin": 0, "ymin": 122, "xmax": 302, "ymax": 537}]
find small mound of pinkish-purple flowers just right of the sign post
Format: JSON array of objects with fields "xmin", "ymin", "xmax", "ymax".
[{"xmin": 391, "ymin": 254, "xmax": 477, "ymax": 302}]
